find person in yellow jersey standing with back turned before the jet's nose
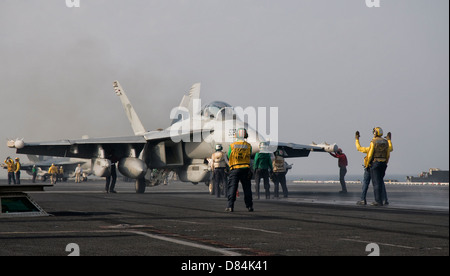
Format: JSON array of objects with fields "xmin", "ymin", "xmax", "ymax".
[{"xmin": 225, "ymin": 128, "xmax": 253, "ymax": 212}]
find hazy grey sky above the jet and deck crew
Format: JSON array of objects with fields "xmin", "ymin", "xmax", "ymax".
[{"xmin": 0, "ymin": 0, "xmax": 449, "ymax": 181}]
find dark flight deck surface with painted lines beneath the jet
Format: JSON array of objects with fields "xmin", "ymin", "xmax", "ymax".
[{"xmin": 0, "ymin": 177, "xmax": 449, "ymax": 258}]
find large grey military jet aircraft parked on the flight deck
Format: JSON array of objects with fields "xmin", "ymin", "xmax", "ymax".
[{"xmin": 8, "ymin": 81, "xmax": 338, "ymax": 193}]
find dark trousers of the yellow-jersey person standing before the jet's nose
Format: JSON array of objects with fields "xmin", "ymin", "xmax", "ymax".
[{"xmin": 227, "ymin": 168, "xmax": 253, "ymax": 209}]
